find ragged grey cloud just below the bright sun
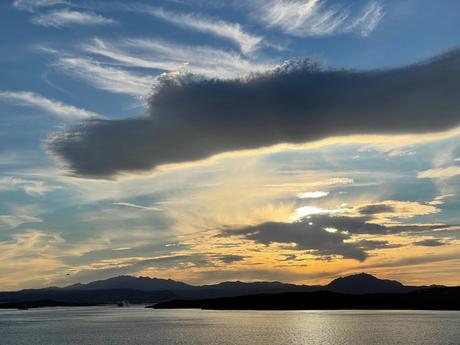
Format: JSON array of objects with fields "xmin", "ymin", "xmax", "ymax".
[{"xmin": 220, "ymin": 215, "xmax": 398, "ymax": 261}]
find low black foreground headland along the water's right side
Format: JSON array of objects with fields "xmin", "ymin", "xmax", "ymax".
[{"xmin": 151, "ymin": 287, "xmax": 460, "ymax": 310}]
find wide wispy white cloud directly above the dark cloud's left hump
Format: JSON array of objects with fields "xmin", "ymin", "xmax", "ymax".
[{"xmin": 83, "ymin": 38, "xmax": 267, "ymax": 78}]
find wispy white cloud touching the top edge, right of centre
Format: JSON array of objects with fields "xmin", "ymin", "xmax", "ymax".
[{"xmin": 252, "ymin": 0, "xmax": 384, "ymax": 37}]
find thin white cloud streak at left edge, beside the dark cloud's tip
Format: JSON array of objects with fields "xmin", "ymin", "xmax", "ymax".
[{"xmin": 0, "ymin": 91, "xmax": 103, "ymax": 120}]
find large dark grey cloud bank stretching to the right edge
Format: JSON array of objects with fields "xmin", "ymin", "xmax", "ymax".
[{"xmin": 50, "ymin": 51, "xmax": 460, "ymax": 177}]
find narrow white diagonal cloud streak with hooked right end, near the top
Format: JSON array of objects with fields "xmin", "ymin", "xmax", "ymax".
[{"xmin": 146, "ymin": 7, "xmax": 263, "ymax": 54}]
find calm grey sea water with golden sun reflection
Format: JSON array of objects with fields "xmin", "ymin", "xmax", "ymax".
[{"xmin": 0, "ymin": 307, "xmax": 460, "ymax": 345}]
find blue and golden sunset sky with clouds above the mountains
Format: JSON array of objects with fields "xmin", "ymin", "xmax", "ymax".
[{"xmin": 0, "ymin": 0, "xmax": 460, "ymax": 290}]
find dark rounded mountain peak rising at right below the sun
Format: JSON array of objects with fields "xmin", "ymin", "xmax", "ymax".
[{"xmin": 325, "ymin": 273, "xmax": 413, "ymax": 294}]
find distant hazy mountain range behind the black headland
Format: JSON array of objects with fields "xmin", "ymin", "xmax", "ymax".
[{"xmin": 0, "ymin": 273, "xmax": 450, "ymax": 308}]
